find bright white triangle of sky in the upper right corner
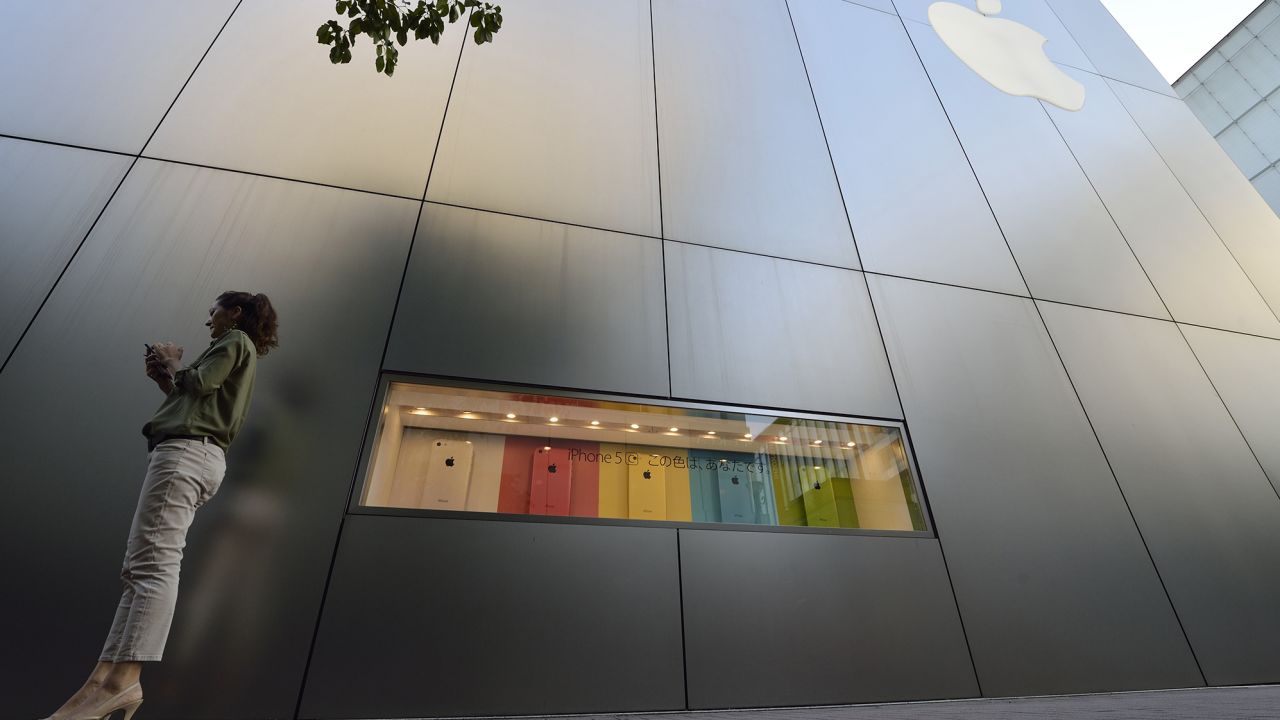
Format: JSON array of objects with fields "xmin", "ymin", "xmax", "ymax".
[{"xmin": 1102, "ymin": 0, "xmax": 1262, "ymax": 83}]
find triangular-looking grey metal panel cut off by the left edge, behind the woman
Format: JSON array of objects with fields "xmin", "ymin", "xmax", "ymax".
[{"xmin": 0, "ymin": 137, "xmax": 131, "ymax": 364}]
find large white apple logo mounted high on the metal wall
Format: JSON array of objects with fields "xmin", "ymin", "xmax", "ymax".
[{"xmin": 929, "ymin": 0, "xmax": 1084, "ymax": 113}]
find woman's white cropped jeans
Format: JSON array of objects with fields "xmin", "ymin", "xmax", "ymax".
[{"xmin": 99, "ymin": 438, "xmax": 227, "ymax": 662}]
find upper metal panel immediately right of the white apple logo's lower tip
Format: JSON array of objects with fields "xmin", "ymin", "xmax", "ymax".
[{"xmin": 1050, "ymin": 70, "xmax": 1280, "ymax": 337}]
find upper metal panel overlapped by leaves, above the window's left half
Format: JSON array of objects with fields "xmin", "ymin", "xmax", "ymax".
[{"xmin": 426, "ymin": 0, "xmax": 662, "ymax": 237}]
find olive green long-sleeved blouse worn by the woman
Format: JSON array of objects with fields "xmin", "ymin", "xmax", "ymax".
[{"xmin": 142, "ymin": 329, "xmax": 257, "ymax": 451}]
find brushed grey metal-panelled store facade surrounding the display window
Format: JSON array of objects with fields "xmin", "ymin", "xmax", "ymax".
[{"xmin": 0, "ymin": 0, "xmax": 1280, "ymax": 719}]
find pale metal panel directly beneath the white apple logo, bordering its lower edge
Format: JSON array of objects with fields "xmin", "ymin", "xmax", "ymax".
[{"xmin": 908, "ymin": 23, "xmax": 1169, "ymax": 318}]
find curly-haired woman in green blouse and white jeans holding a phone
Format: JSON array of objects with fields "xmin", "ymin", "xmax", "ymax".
[{"xmin": 46, "ymin": 292, "xmax": 279, "ymax": 720}]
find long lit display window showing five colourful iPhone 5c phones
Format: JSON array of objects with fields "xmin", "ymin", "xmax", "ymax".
[{"xmin": 358, "ymin": 382, "xmax": 927, "ymax": 532}]
